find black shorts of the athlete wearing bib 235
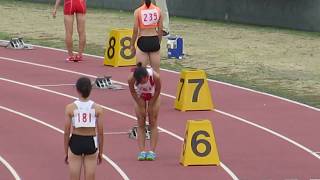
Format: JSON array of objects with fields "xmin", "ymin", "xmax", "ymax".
[{"xmin": 137, "ymin": 36, "xmax": 160, "ymax": 53}]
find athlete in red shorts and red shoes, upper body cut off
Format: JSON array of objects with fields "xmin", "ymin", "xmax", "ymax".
[{"xmin": 52, "ymin": 0, "xmax": 87, "ymax": 61}]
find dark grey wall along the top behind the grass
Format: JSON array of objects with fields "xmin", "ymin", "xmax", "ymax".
[{"xmin": 25, "ymin": 0, "xmax": 320, "ymax": 32}]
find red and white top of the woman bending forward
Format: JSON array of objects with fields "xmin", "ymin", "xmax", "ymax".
[{"xmin": 135, "ymin": 68, "xmax": 155, "ymax": 101}]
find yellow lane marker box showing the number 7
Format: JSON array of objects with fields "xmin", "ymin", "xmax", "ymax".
[{"xmin": 175, "ymin": 70, "xmax": 213, "ymax": 111}]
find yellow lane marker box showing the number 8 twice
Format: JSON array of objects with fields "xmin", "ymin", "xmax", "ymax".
[{"xmin": 104, "ymin": 29, "xmax": 136, "ymax": 67}]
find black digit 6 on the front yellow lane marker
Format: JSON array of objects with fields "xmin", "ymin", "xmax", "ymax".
[{"xmin": 191, "ymin": 130, "xmax": 211, "ymax": 157}]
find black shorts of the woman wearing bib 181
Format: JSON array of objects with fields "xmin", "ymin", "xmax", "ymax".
[{"xmin": 69, "ymin": 134, "xmax": 97, "ymax": 156}]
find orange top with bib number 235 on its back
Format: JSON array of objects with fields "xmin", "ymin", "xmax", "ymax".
[{"xmin": 138, "ymin": 3, "xmax": 161, "ymax": 29}]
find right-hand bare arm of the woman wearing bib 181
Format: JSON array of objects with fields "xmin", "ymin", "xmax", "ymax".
[{"xmin": 96, "ymin": 105, "xmax": 104, "ymax": 164}]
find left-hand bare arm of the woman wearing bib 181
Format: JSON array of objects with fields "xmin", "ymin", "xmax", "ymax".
[{"xmin": 64, "ymin": 104, "xmax": 72, "ymax": 163}]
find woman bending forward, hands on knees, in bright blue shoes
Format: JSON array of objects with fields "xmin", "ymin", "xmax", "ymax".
[{"xmin": 128, "ymin": 62, "xmax": 161, "ymax": 161}]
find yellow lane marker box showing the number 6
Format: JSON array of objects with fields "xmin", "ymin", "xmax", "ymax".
[{"xmin": 180, "ymin": 120, "xmax": 220, "ymax": 166}]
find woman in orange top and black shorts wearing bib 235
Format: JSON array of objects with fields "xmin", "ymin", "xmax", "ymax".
[{"xmin": 131, "ymin": 0, "xmax": 163, "ymax": 73}]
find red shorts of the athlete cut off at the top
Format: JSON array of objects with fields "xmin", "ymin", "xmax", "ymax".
[{"xmin": 64, "ymin": 0, "xmax": 87, "ymax": 15}]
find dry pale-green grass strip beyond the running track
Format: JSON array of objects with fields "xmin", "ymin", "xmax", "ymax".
[{"xmin": 0, "ymin": 0, "xmax": 320, "ymax": 108}]
